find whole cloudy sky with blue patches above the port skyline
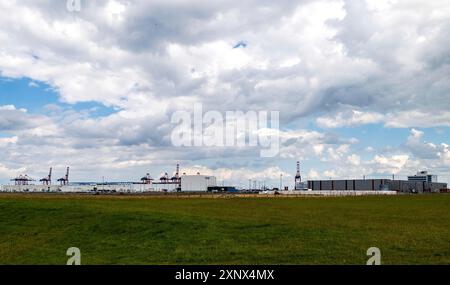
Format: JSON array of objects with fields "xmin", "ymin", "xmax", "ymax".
[{"xmin": 0, "ymin": 0, "xmax": 450, "ymax": 187}]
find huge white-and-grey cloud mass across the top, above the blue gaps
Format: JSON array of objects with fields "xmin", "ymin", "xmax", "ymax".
[{"xmin": 0, "ymin": 0, "xmax": 450, "ymax": 121}]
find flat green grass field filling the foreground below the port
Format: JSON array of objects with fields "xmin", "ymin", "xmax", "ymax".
[{"xmin": 0, "ymin": 194, "xmax": 450, "ymax": 265}]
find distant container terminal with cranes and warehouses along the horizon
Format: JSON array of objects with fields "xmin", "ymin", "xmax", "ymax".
[{"xmin": 0, "ymin": 162, "xmax": 450, "ymax": 196}]
